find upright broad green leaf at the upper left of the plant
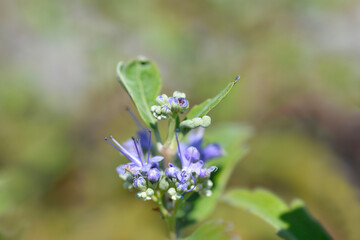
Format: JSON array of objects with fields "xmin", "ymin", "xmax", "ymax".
[{"xmin": 116, "ymin": 59, "xmax": 161, "ymax": 127}]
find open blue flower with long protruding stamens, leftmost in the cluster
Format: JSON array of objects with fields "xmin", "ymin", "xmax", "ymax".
[{"xmin": 105, "ymin": 131, "xmax": 164, "ymax": 175}]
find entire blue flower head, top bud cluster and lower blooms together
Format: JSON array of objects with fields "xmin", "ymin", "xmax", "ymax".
[{"xmin": 105, "ymin": 91, "xmax": 224, "ymax": 202}]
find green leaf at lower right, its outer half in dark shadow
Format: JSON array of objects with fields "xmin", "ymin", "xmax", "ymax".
[{"xmin": 224, "ymin": 189, "xmax": 332, "ymax": 240}]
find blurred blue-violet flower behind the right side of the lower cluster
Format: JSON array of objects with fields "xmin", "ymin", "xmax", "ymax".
[{"xmin": 180, "ymin": 128, "xmax": 224, "ymax": 162}]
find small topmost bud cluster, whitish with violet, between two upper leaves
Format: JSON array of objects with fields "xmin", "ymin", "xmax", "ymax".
[{"xmin": 150, "ymin": 91, "xmax": 189, "ymax": 120}]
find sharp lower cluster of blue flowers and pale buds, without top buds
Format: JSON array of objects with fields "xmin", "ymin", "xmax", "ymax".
[{"xmin": 105, "ymin": 131, "xmax": 222, "ymax": 201}]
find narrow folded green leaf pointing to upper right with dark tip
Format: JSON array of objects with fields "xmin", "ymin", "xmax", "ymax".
[{"xmin": 186, "ymin": 78, "xmax": 238, "ymax": 119}]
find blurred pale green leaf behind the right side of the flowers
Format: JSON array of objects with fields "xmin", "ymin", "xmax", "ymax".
[{"xmin": 187, "ymin": 123, "xmax": 252, "ymax": 222}]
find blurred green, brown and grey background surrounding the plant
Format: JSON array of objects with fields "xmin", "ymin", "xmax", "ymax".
[{"xmin": 0, "ymin": 0, "xmax": 360, "ymax": 240}]
